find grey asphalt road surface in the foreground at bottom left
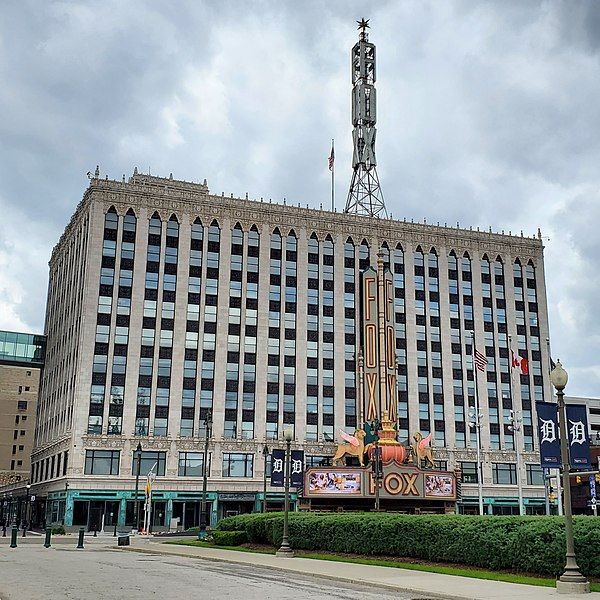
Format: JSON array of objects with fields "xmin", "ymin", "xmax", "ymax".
[{"xmin": 0, "ymin": 544, "xmax": 424, "ymax": 600}]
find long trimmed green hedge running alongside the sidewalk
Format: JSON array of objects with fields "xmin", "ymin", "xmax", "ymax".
[{"xmin": 215, "ymin": 513, "xmax": 600, "ymax": 577}]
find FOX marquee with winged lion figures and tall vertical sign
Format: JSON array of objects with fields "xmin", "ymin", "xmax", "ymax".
[{"xmin": 303, "ymin": 253, "xmax": 460, "ymax": 513}]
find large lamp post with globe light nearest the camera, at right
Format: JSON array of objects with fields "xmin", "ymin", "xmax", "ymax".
[{"xmin": 550, "ymin": 360, "xmax": 590, "ymax": 594}]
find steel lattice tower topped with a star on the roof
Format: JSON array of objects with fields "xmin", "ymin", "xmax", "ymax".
[{"xmin": 344, "ymin": 19, "xmax": 387, "ymax": 217}]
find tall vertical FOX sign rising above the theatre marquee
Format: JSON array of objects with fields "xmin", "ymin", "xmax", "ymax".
[{"xmin": 362, "ymin": 251, "xmax": 398, "ymax": 423}]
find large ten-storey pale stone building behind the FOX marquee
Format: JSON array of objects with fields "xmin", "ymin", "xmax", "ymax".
[{"xmin": 27, "ymin": 165, "xmax": 551, "ymax": 526}]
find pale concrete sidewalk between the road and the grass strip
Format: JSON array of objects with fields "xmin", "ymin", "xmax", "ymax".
[{"xmin": 120, "ymin": 538, "xmax": 600, "ymax": 600}]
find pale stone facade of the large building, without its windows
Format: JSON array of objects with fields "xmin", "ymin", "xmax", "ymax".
[{"xmin": 28, "ymin": 172, "xmax": 550, "ymax": 520}]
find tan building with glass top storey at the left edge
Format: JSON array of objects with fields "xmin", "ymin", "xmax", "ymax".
[{"xmin": 0, "ymin": 331, "xmax": 46, "ymax": 521}]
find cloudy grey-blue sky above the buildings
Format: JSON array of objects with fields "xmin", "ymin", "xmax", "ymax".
[{"xmin": 0, "ymin": 0, "xmax": 600, "ymax": 396}]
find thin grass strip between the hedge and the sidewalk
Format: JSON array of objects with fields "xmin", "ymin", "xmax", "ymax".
[{"xmin": 164, "ymin": 540, "xmax": 600, "ymax": 592}]
